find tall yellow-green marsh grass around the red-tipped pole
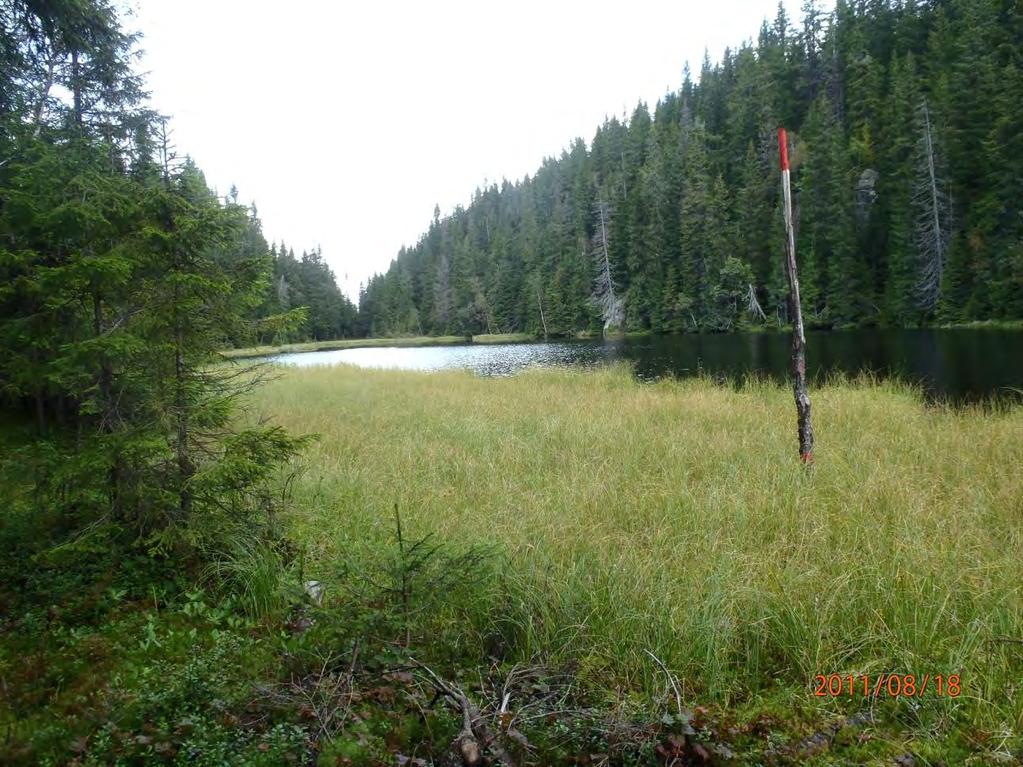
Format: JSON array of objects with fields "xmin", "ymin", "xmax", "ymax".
[{"xmin": 251, "ymin": 367, "xmax": 1023, "ymax": 734}]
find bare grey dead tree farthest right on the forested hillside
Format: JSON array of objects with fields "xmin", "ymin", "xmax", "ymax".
[{"xmin": 913, "ymin": 99, "xmax": 951, "ymax": 311}]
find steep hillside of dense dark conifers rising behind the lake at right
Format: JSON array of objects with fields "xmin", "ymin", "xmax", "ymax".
[{"xmin": 359, "ymin": 0, "xmax": 1023, "ymax": 335}]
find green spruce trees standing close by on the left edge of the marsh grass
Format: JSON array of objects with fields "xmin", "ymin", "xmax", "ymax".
[{"xmin": 0, "ymin": 0, "xmax": 303, "ymax": 554}]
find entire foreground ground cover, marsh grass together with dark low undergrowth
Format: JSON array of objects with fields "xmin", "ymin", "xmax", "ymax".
[{"xmin": 6, "ymin": 367, "xmax": 1023, "ymax": 764}]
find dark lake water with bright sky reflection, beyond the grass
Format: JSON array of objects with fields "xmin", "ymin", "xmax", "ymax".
[{"xmin": 275, "ymin": 329, "xmax": 1023, "ymax": 401}]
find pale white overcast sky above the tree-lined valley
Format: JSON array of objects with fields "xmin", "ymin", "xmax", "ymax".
[{"xmin": 129, "ymin": 0, "xmax": 799, "ymax": 297}]
